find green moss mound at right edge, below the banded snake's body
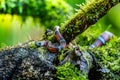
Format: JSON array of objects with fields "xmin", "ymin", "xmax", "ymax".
[{"xmin": 92, "ymin": 37, "xmax": 120, "ymax": 80}]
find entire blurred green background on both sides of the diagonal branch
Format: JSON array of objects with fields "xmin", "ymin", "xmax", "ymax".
[{"xmin": 0, "ymin": 0, "xmax": 120, "ymax": 48}]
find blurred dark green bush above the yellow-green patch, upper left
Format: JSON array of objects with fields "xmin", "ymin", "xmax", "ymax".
[{"xmin": 0, "ymin": 0, "xmax": 72, "ymax": 28}]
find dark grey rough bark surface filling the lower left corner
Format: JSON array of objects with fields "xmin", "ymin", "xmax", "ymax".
[{"xmin": 0, "ymin": 46, "xmax": 56, "ymax": 80}]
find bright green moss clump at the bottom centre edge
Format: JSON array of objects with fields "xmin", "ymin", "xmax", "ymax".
[{"xmin": 56, "ymin": 63, "xmax": 87, "ymax": 80}]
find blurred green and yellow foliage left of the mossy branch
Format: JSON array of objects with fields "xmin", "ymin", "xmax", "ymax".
[{"xmin": 0, "ymin": 0, "xmax": 72, "ymax": 47}]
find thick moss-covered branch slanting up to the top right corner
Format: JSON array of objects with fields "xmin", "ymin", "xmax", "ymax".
[{"xmin": 48, "ymin": 0, "xmax": 120, "ymax": 43}]
